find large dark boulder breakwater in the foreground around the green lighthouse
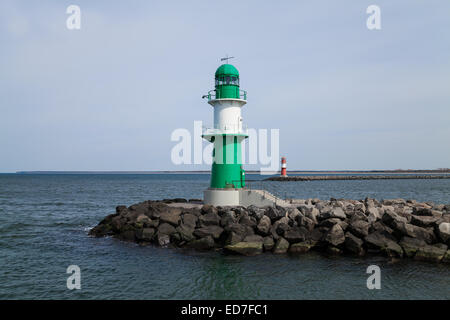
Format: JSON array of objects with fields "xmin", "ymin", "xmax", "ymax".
[{"xmin": 90, "ymin": 198, "xmax": 450, "ymax": 263}]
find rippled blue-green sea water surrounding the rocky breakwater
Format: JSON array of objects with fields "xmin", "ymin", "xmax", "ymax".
[{"xmin": 0, "ymin": 174, "xmax": 450, "ymax": 299}]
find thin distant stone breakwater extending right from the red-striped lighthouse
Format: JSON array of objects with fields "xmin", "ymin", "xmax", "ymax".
[{"xmin": 264, "ymin": 174, "xmax": 450, "ymax": 181}]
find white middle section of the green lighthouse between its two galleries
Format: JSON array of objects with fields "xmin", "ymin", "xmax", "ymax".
[{"xmin": 209, "ymin": 99, "xmax": 247, "ymax": 134}]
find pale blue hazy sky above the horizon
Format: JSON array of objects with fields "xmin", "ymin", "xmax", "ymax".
[{"xmin": 0, "ymin": 0, "xmax": 450, "ymax": 172}]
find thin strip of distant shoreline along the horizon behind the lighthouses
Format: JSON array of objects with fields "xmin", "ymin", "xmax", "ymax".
[{"xmin": 9, "ymin": 169, "xmax": 450, "ymax": 175}]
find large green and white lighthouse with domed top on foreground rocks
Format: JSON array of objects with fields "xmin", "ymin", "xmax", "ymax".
[{"xmin": 202, "ymin": 58, "xmax": 248, "ymax": 206}]
